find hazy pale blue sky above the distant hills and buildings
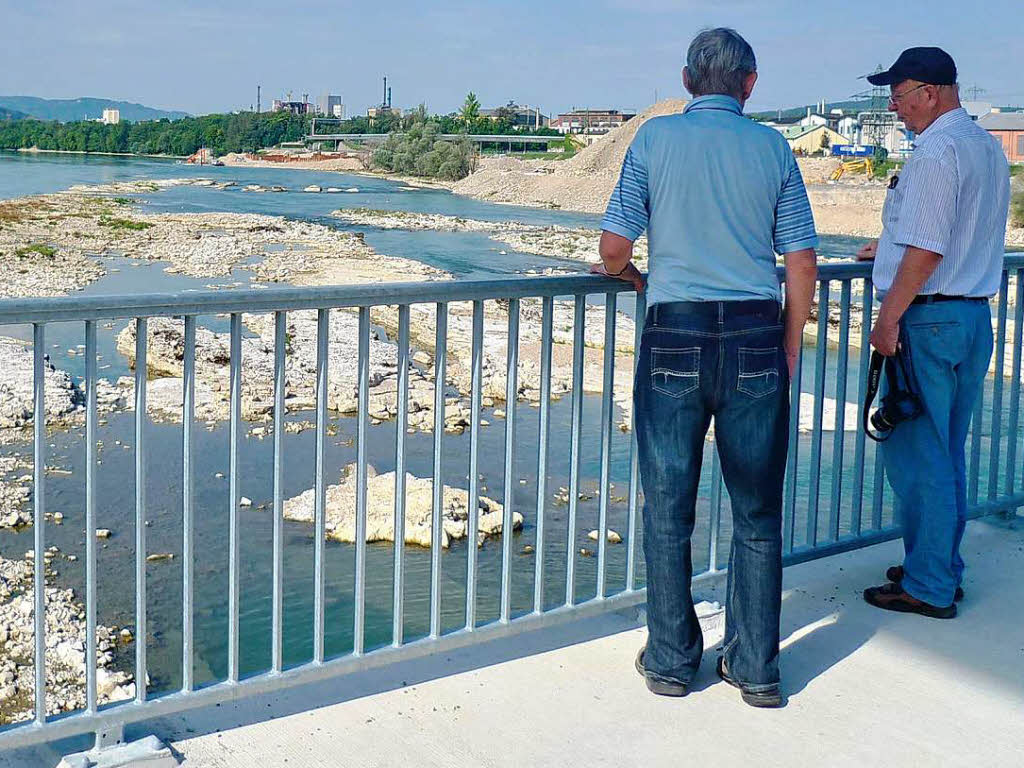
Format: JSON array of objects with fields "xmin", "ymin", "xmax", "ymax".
[{"xmin": 0, "ymin": 0, "xmax": 1024, "ymax": 114}]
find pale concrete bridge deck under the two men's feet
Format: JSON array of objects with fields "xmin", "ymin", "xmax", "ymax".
[{"xmin": 6, "ymin": 518, "xmax": 1024, "ymax": 768}]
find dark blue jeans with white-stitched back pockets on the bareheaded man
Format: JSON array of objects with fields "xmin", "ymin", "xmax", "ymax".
[{"xmin": 634, "ymin": 301, "xmax": 790, "ymax": 690}]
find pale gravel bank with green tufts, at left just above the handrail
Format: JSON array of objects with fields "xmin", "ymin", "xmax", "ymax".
[{"xmin": 0, "ymin": 179, "xmax": 438, "ymax": 298}]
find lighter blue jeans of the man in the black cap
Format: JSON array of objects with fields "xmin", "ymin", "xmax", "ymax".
[{"xmin": 882, "ymin": 301, "xmax": 992, "ymax": 606}]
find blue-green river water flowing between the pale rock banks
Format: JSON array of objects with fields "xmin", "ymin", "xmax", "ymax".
[{"xmin": 0, "ymin": 154, "xmax": 1020, "ymax": 704}]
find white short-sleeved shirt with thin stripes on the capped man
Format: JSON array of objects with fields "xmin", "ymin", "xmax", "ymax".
[{"xmin": 872, "ymin": 109, "xmax": 1010, "ymax": 297}]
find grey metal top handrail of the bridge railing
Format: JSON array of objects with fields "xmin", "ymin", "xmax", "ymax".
[{"xmin": 0, "ymin": 253, "xmax": 1024, "ymax": 325}]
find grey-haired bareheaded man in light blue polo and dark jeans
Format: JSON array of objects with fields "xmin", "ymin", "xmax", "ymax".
[{"xmin": 594, "ymin": 29, "xmax": 817, "ymax": 707}]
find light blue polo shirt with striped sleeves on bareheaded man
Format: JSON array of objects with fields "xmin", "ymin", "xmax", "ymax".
[{"xmin": 601, "ymin": 94, "xmax": 818, "ymax": 305}]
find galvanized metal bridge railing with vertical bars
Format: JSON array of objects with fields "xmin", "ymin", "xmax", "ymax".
[{"xmin": 0, "ymin": 255, "xmax": 1024, "ymax": 749}]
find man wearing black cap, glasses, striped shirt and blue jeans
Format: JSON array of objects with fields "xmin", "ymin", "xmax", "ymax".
[{"xmin": 858, "ymin": 48, "xmax": 1010, "ymax": 618}]
